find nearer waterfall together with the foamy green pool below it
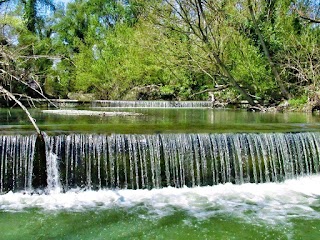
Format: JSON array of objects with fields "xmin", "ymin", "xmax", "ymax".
[{"xmin": 0, "ymin": 132, "xmax": 320, "ymax": 239}]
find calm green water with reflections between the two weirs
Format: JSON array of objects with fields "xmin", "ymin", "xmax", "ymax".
[{"xmin": 0, "ymin": 108, "xmax": 320, "ymax": 133}]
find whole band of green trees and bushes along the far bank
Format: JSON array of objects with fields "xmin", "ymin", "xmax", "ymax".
[{"xmin": 0, "ymin": 0, "xmax": 320, "ymax": 104}]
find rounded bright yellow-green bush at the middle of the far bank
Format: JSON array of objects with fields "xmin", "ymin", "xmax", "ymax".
[{"xmin": 67, "ymin": 24, "xmax": 195, "ymax": 99}]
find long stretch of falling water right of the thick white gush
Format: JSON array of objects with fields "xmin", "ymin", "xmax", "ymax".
[{"xmin": 48, "ymin": 133, "xmax": 320, "ymax": 189}]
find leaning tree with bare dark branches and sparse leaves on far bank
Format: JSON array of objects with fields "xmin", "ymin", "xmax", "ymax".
[{"xmin": 147, "ymin": 0, "xmax": 255, "ymax": 105}]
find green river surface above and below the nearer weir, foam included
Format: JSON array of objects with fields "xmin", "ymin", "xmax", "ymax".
[{"xmin": 0, "ymin": 108, "xmax": 320, "ymax": 240}]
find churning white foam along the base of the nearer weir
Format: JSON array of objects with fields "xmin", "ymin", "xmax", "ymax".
[{"xmin": 0, "ymin": 176, "xmax": 320, "ymax": 223}]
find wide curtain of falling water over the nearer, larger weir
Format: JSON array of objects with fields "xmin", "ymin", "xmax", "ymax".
[{"xmin": 0, "ymin": 132, "xmax": 320, "ymax": 193}]
